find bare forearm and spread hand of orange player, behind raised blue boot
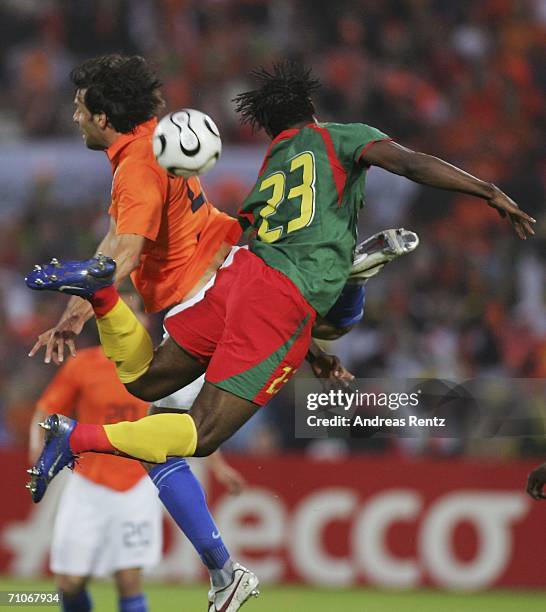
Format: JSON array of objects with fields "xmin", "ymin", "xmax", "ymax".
[{"xmin": 29, "ymin": 220, "xmax": 146, "ymax": 365}]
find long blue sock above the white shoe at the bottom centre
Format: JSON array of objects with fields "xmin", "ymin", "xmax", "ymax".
[{"xmin": 149, "ymin": 457, "xmax": 231, "ymax": 586}]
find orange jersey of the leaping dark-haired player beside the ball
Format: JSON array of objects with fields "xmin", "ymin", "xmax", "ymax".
[{"xmin": 106, "ymin": 119, "xmax": 241, "ymax": 312}]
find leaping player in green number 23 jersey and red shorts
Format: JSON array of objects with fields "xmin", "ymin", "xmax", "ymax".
[{"xmin": 27, "ymin": 63, "xmax": 535, "ymax": 504}]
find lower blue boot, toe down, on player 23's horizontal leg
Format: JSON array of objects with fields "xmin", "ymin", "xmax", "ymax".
[{"xmin": 26, "ymin": 414, "xmax": 77, "ymax": 504}]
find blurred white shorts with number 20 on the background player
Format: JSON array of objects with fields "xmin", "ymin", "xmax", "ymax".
[{"xmin": 50, "ymin": 473, "xmax": 163, "ymax": 577}]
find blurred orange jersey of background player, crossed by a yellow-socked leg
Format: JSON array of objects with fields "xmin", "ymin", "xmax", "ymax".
[{"xmin": 38, "ymin": 347, "xmax": 148, "ymax": 491}]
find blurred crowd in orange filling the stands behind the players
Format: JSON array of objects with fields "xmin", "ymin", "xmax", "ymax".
[{"xmin": 0, "ymin": 0, "xmax": 546, "ymax": 453}]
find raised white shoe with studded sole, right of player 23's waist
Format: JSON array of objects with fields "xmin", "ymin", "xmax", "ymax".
[{"xmin": 348, "ymin": 227, "xmax": 419, "ymax": 283}]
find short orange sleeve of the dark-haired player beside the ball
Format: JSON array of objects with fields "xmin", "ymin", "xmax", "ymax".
[{"xmin": 111, "ymin": 161, "xmax": 167, "ymax": 240}]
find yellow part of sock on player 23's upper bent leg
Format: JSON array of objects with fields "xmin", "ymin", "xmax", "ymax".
[{"xmin": 97, "ymin": 298, "xmax": 154, "ymax": 384}]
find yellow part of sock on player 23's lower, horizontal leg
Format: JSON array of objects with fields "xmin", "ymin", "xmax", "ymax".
[{"xmin": 104, "ymin": 413, "xmax": 197, "ymax": 463}]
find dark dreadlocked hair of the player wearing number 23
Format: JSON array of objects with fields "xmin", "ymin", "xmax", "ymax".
[{"xmin": 233, "ymin": 61, "xmax": 321, "ymax": 137}]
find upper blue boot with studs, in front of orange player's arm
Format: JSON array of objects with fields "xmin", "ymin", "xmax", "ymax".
[{"xmin": 25, "ymin": 253, "xmax": 116, "ymax": 298}]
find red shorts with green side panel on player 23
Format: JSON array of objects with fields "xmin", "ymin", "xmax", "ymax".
[{"xmin": 164, "ymin": 249, "xmax": 315, "ymax": 405}]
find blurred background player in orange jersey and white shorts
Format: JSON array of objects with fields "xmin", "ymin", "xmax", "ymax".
[{"xmin": 29, "ymin": 346, "xmax": 244, "ymax": 612}]
